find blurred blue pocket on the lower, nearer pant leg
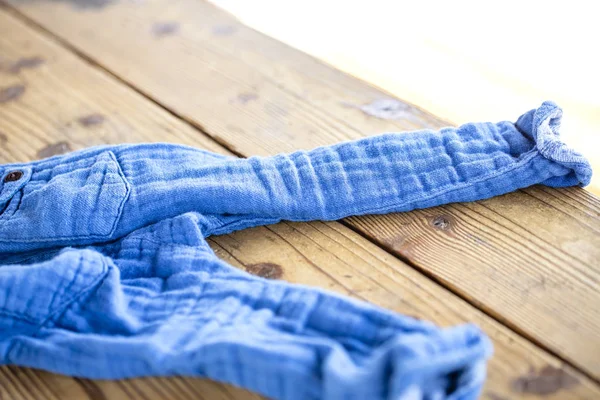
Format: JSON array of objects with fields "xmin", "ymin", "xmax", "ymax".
[{"xmin": 0, "ymin": 249, "xmax": 112, "ymax": 362}]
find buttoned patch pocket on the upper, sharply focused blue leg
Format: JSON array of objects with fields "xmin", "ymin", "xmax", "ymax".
[{"xmin": 0, "ymin": 151, "xmax": 129, "ymax": 244}]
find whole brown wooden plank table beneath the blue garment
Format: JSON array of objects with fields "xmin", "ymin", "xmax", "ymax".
[{"xmin": 0, "ymin": 0, "xmax": 600, "ymax": 400}]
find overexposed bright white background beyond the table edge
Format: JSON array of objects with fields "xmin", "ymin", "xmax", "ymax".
[{"xmin": 213, "ymin": 0, "xmax": 600, "ymax": 194}]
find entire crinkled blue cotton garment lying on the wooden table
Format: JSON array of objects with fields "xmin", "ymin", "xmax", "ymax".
[{"xmin": 0, "ymin": 102, "xmax": 591, "ymax": 399}]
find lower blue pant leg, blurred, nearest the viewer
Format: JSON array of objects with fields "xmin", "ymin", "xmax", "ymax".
[{"xmin": 0, "ymin": 211, "xmax": 491, "ymax": 399}]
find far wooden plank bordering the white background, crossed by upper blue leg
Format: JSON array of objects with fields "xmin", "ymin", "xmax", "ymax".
[{"xmin": 3, "ymin": 0, "xmax": 600, "ymax": 378}]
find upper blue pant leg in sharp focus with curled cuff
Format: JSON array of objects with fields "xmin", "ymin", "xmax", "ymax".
[{"xmin": 0, "ymin": 102, "xmax": 591, "ymax": 254}]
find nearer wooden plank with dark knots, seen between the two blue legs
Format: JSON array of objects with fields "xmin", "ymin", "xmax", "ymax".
[{"xmin": 0, "ymin": 6, "xmax": 600, "ymax": 400}]
